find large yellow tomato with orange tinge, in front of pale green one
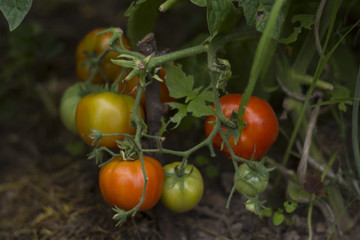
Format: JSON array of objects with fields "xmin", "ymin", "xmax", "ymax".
[{"xmin": 76, "ymin": 92, "xmax": 144, "ymax": 148}]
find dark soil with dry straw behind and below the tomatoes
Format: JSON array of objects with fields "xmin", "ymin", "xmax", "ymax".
[{"xmin": 0, "ymin": 0, "xmax": 360, "ymax": 240}]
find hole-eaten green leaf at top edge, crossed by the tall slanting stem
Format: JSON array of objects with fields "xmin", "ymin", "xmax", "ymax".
[{"xmin": 239, "ymin": 0, "xmax": 285, "ymax": 39}]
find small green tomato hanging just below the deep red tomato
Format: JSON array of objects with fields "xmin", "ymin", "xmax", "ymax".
[{"xmin": 234, "ymin": 162, "xmax": 269, "ymax": 197}]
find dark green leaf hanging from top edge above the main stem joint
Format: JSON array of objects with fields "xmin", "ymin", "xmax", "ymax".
[{"xmin": 207, "ymin": 0, "xmax": 240, "ymax": 38}]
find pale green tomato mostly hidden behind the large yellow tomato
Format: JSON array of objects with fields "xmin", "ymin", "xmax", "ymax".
[{"xmin": 59, "ymin": 82, "xmax": 100, "ymax": 133}]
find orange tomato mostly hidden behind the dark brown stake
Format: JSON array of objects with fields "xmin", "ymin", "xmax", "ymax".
[{"xmin": 119, "ymin": 68, "xmax": 175, "ymax": 107}]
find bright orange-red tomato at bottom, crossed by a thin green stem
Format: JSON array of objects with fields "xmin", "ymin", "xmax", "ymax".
[{"xmin": 99, "ymin": 156, "xmax": 164, "ymax": 211}]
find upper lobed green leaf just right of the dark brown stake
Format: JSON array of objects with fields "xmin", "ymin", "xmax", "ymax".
[{"xmin": 164, "ymin": 63, "xmax": 194, "ymax": 98}]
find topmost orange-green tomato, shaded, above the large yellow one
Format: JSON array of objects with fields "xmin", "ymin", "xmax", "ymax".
[{"xmin": 76, "ymin": 28, "xmax": 130, "ymax": 83}]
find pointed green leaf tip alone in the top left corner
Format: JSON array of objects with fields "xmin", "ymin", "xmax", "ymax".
[{"xmin": 0, "ymin": 0, "xmax": 32, "ymax": 31}]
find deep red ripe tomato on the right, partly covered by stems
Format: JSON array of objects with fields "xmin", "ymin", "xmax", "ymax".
[{"xmin": 205, "ymin": 94, "xmax": 279, "ymax": 160}]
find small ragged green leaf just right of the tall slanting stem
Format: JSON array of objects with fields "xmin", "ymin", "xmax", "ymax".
[{"xmin": 279, "ymin": 14, "xmax": 315, "ymax": 44}]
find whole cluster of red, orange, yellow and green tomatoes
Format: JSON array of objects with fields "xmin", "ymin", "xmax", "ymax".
[{"xmin": 60, "ymin": 28, "xmax": 279, "ymax": 218}]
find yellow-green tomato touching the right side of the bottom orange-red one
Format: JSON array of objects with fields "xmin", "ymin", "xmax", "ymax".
[{"xmin": 160, "ymin": 162, "xmax": 204, "ymax": 213}]
